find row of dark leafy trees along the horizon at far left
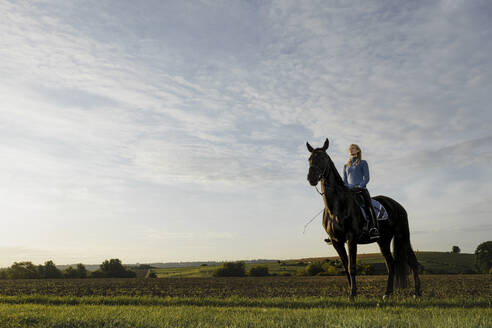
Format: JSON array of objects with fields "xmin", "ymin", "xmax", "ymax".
[{"xmin": 0, "ymin": 259, "xmax": 136, "ymax": 279}]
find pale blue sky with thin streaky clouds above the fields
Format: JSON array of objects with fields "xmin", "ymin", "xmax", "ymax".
[{"xmin": 0, "ymin": 0, "xmax": 492, "ymax": 266}]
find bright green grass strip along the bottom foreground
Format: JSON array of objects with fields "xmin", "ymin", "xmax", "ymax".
[{"xmin": 0, "ymin": 296, "xmax": 492, "ymax": 328}]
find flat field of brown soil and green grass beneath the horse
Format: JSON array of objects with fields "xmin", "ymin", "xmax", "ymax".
[{"xmin": 0, "ymin": 275, "xmax": 492, "ymax": 327}]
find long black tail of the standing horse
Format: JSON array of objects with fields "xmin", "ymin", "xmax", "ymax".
[{"xmin": 393, "ymin": 202, "xmax": 419, "ymax": 288}]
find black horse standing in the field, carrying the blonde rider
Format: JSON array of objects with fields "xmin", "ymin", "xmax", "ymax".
[{"xmin": 306, "ymin": 139, "xmax": 421, "ymax": 298}]
